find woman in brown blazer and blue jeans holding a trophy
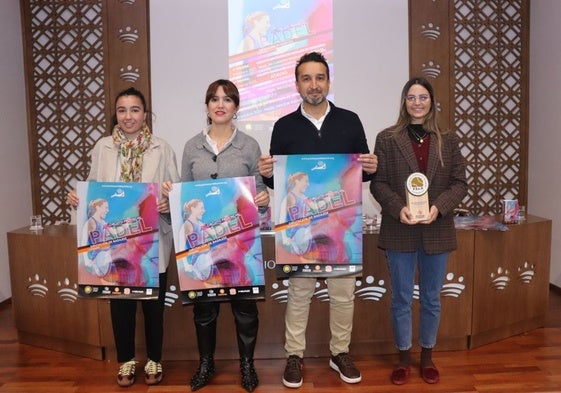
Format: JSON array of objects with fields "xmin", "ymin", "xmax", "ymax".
[{"xmin": 370, "ymin": 78, "xmax": 467, "ymax": 385}]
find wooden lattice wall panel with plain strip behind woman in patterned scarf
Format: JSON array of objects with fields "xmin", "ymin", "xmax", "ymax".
[{"xmin": 22, "ymin": 0, "xmax": 150, "ymax": 224}]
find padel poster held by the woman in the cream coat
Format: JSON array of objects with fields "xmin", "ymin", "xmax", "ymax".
[{"xmin": 76, "ymin": 182, "xmax": 159, "ymax": 299}]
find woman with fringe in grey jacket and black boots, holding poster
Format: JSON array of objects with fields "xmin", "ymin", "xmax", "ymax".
[{"xmin": 181, "ymin": 79, "xmax": 269, "ymax": 392}]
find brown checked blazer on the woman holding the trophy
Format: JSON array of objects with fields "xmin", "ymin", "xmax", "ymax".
[{"xmin": 370, "ymin": 129, "xmax": 467, "ymax": 254}]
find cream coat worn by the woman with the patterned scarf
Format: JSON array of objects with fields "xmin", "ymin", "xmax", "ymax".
[{"xmin": 87, "ymin": 135, "xmax": 179, "ymax": 273}]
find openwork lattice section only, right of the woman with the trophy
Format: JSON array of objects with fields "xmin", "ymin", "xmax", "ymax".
[{"xmin": 453, "ymin": 0, "xmax": 528, "ymax": 214}]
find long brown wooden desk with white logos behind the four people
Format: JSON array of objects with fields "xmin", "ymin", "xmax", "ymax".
[{"xmin": 8, "ymin": 216, "xmax": 551, "ymax": 360}]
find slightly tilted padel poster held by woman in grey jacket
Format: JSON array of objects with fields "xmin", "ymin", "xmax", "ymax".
[{"xmin": 169, "ymin": 176, "xmax": 265, "ymax": 304}]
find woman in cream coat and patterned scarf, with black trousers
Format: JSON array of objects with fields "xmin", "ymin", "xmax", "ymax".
[{"xmin": 68, "ymin": 88, "xmax": 179, "ymax": 386}]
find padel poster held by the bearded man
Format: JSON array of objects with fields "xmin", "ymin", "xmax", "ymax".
[{"xmin": 273, "ymin": 154, "xmax": 362, "ymax": 277}]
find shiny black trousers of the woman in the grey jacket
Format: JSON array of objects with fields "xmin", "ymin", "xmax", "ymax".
[{"xmin": 193, "ymin": 300, "xmax": 259, "ymax": 359}]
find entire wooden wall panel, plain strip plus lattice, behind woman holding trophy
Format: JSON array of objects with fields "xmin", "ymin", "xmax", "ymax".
[{"xmin": 409, "ymin": 0, "xmax": 529, "ymax": 215}]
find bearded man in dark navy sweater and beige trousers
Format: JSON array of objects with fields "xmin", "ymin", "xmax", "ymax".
[{"xmin": 259, "ymin": 52, "xmax": 378, "ymax": 388}]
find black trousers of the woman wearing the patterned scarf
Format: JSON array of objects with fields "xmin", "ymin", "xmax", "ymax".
[{"xmin": 110, "ymin": 273, "xmax": 167, "ymax": 363}]
